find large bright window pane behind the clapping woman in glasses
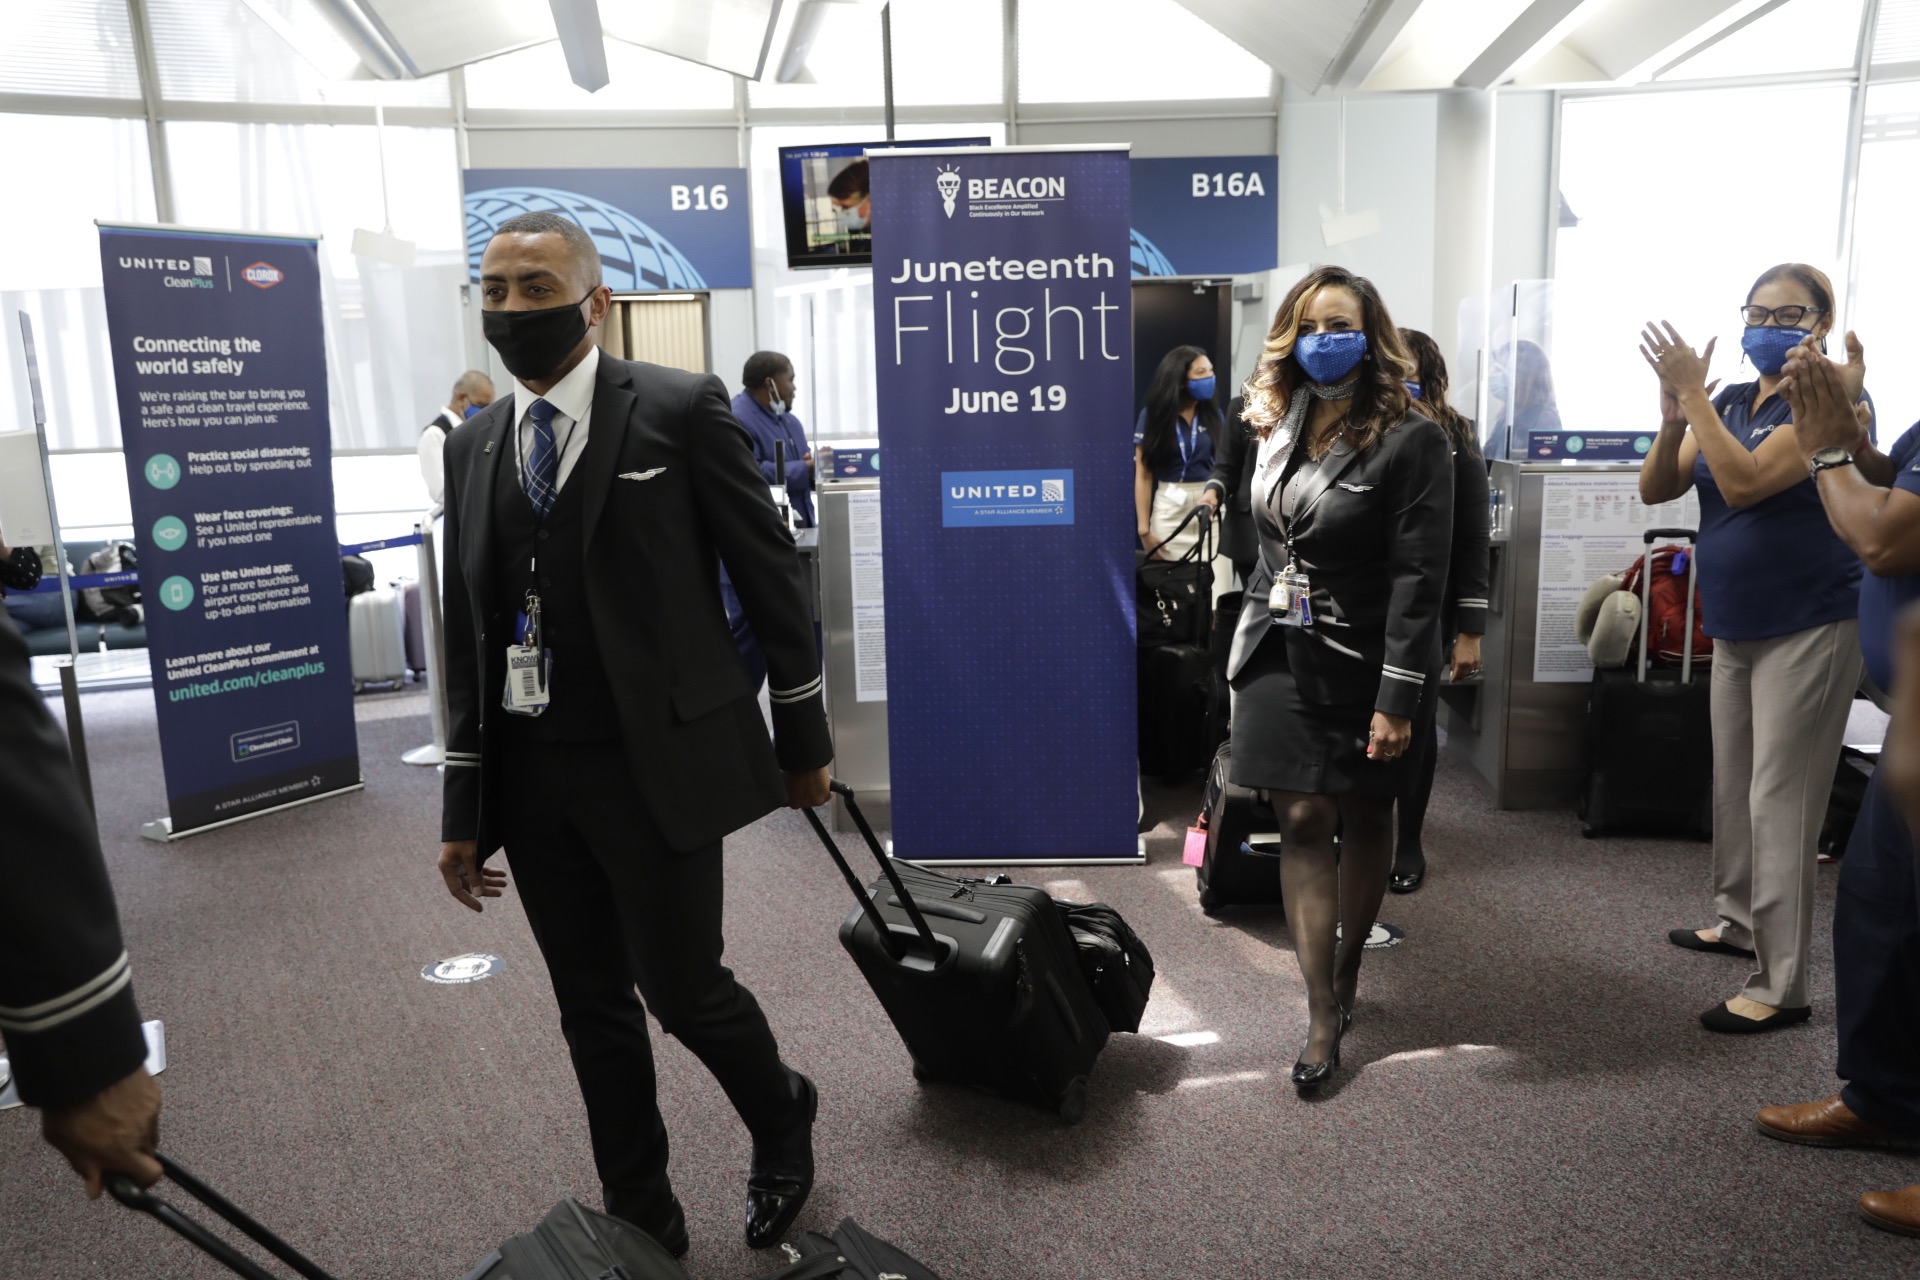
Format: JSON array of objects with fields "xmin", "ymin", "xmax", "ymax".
[{"xmin": 1553, "ymin": 84, "xmax": 1851, "ymax": 430}]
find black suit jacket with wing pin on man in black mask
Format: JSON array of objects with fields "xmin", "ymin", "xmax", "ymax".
[{"xmin": 442, "ymin": 353, "xmax": 833, "ymax": 858}]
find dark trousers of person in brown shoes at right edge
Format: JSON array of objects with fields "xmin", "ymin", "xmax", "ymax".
[{"xmin": 1834, "ymin": 771, "xmax": 1920, "ymax": 1134}]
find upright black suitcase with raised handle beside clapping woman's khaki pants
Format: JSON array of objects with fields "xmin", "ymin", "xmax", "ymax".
[{"xmin": 1578, "ymin": 530, "xmax": 1713, "ymax": 839}]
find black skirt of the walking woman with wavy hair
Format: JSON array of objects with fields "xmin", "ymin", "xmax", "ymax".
[{"xmin": 1231, "ymin": 628, "xmax": 1407, "ymax": 796}]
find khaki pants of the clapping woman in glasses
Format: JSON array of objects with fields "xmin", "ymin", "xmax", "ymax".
[{"xmin": 1713, "ymin": 618, "xmax": 1860, "ymax": 1009}]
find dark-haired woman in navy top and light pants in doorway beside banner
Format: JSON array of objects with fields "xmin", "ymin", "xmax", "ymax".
[{"xmin": 1133, "ymin": 347, "xmax": 1227, "ymax": 571}]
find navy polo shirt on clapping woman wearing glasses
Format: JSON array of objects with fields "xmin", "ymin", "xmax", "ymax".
[{"xmin": 1693, "ymin": 382, "xmax": 1872, "ymax": 641}]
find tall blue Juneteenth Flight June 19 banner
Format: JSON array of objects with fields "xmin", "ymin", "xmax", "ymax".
[{"xmin": 870, "ymin": 148, "xmax": 1139, "ymax": 864}]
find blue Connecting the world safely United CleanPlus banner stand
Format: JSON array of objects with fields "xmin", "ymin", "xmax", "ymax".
[{"xmin": 100, "ymin": 225, "xmax": 361, "ymax": 839}]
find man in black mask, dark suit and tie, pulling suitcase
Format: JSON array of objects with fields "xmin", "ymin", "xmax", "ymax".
[{"xmin": 440, "ymin": 213, "xmax": 833, "ymax": 1255}]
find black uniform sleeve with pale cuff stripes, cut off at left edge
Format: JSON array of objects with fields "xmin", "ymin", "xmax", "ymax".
[{"xmin": 0, "ymin": 610, "xmax": 146, "ymax": 1107}]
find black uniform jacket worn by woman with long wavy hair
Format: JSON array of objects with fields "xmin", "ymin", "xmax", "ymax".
[{"xmin": 1227, "ymin": 413, "xmax": 1453, "ymax": 720}]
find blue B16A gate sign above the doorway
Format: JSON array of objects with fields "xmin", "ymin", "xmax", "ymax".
[{"xmin": 1129, "ymin": 155, "xmax": 1281, "ymax": 276}]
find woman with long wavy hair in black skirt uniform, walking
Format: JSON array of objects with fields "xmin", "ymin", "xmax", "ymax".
[{"xmin": 1227, "ymin": 267, "xmax": 1453, "ymax": 1090}]
